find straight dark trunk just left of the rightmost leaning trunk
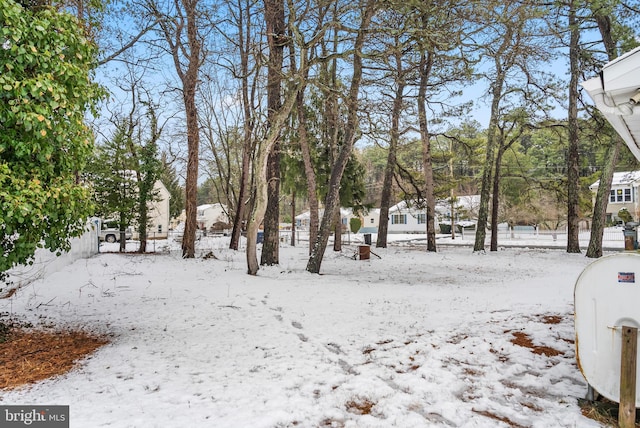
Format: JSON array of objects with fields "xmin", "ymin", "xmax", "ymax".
[{"xmin": 567, "ymin": 1, "xmax": 580, "ymax": 253}]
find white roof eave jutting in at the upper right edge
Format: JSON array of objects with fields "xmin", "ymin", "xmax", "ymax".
[{"xmin": 582, "ymin": 47, "xmax": 640, "ymax": 159}]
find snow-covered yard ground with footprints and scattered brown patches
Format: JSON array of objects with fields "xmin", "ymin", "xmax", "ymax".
[{"xmin": 0, "ymin": 237, "xmax": 620, "ymax": 428}]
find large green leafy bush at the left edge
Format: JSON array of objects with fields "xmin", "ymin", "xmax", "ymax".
[{"xmin": 0, "ymin": 0, "xmax": 104, "ymax": 277}]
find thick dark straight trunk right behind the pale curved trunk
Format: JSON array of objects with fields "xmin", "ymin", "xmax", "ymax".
[{"xmin": 260, "ymin": 0, "xmax": 287, "ymax": 266}]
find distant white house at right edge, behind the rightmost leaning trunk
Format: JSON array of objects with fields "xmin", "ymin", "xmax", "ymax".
[{"xmin": 589, "ymin": 171, "xmax": 640, "ymax": 223}]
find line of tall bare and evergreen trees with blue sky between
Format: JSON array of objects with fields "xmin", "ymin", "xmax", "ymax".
[{"xmin": 3, "ymin": 0, "xmax": 638, "ymax": 274}]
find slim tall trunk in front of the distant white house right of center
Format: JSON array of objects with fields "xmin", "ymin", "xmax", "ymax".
[{"xmin": 418, "ymin": 52, "xmax": 438, "ymax": 252}]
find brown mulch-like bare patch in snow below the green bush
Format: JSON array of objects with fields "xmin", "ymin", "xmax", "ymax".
[{"xmin": 0, "ymin": 322, "xmax": 108, "ymax": 390}]
